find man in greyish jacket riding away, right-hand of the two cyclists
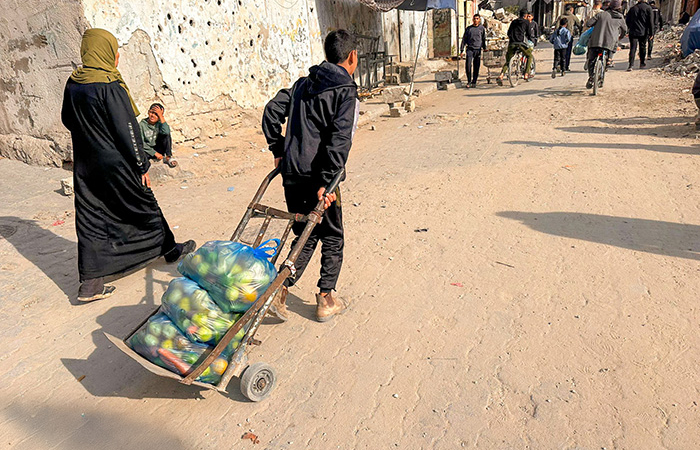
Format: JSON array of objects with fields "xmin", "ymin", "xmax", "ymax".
[{"xmin": 586, "ymin": 0, "xmax": 627, "ymax": 89}]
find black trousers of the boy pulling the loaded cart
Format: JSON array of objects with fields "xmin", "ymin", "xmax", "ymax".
[{"xmin": 284, "ymin": 184, "xmax": 345, "ymax": 292}]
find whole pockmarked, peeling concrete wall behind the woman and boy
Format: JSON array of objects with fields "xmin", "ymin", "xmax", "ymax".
[{"xmin": 0, "ymin": 0, "xmax": 427, "ymax": 165}]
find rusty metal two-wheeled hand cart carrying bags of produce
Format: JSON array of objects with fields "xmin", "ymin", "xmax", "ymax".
[{"xmin": 105, "ymin": 168, "xmax": 345, "ymax": 402}]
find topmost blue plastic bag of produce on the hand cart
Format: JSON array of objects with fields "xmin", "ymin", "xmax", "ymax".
[{"xmin": 177, "ymin": 239, "xmax": 280, "ymax": 313}]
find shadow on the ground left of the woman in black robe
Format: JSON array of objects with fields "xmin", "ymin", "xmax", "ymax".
[{"xmin": 0, "ymin": 216, "xmax": 79, "ymax": 302}]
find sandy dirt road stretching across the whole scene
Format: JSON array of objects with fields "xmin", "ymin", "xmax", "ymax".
[{"xmin": 0, "ymin": 46, "xmax": 700, "ymax": 449}]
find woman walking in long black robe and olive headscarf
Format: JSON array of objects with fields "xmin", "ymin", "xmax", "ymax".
[{"xmin": 61, "ymin": 28, "xmax": 195, "ymax": 302}]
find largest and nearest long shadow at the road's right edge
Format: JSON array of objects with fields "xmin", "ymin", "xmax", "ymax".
[{"xmin": 497, "ymin": 211, "xmax": 700, "ymax": 261}]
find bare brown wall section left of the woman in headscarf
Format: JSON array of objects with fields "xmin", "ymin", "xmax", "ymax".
[{"xmin": 0, "ymin": 0, "xmax": 87, "ymax": 165}]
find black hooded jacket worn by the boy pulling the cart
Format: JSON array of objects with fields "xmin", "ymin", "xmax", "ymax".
[{"xmin": 262, "ymin": 61, "xmax": 360, "ymax": 188}]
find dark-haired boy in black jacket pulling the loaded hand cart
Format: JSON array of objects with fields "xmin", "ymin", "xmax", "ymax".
[{"xmin": 262, "ymin": 30, "xmax": 360, "ymax": 322}]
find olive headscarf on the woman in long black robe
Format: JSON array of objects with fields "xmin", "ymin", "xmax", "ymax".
[{"xmin": 70, "ymin": 28, "xmax": 140, "ymax": 116}]
